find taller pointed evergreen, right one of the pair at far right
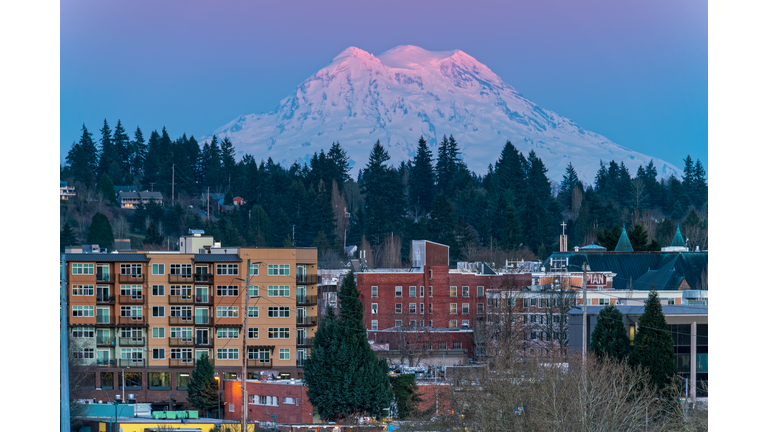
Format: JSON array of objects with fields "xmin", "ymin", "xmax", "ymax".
[{"xmin": 629, "ymin": 287, "xmax": 677, "ymax": 396}]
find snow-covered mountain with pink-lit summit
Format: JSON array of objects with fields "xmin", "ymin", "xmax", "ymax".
[{"xmin": 208, "ymin": 45, "xmax": 681, "ymax": 183}]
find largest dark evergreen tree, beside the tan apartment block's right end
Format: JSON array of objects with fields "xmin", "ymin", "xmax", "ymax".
[{"xmin": 304, "ymin": 272, "xmax": 394, "ymax": 421}]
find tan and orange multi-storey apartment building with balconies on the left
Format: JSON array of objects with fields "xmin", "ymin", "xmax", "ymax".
[{"xmin": 66, "ymin": 243, "xmax": 318, "ymax": 407}]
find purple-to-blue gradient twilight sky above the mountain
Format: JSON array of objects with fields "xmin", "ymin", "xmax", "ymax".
[{"xmin": 60, "ymin": 0, "xmax": 708, "ymax": 174}]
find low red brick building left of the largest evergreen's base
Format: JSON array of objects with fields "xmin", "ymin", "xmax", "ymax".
[{"xmin": 222, "ymin": 380, "xmax": 312, "ymax": 424}]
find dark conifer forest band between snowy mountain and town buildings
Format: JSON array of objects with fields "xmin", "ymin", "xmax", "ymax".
[{"xmin": 61, "ymin": 120, "xmax": 707, "ymax": 267}]
